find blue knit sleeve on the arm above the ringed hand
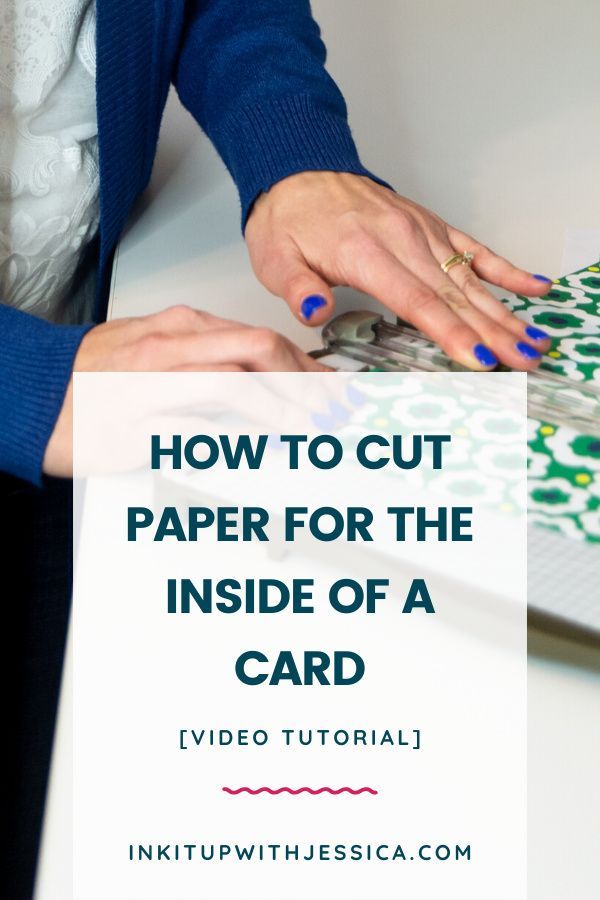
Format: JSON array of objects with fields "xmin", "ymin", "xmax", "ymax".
[{"xmin": 173, "ymin": 0, "xmax": 378, "ymax": 225}]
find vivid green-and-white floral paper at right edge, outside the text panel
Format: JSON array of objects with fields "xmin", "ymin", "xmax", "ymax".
[{"xmin": 505, "ymin": 263, "xmax": 600, "ymax": 543}]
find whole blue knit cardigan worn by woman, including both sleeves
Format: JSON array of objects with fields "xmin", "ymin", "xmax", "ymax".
[{"xmin": 0, "ymin": 0, "xmax": 378, "ymax": 484}]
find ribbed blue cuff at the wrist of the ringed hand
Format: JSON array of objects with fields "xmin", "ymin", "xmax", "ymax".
[{"xmin": 215, "ymin": 95, "xmax": 390, "ymax": 229}]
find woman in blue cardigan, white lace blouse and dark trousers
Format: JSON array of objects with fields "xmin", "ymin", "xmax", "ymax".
[{"xmin": 0, "ymin": 0, "xmax": 550, "ymax": 900}]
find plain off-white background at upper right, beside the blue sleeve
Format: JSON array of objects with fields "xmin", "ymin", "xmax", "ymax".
[{"xmin": 315, "ymin": 0, "xmax": 600, "ymax": 274}]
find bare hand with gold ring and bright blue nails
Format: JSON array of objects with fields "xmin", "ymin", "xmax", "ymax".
[{"xmin": 246, "ymin": 172, "xmax": 551, "ymax": 370}]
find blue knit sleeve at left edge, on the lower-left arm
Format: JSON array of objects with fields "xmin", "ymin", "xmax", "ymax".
[{"xmin": 0, "ymin": 306, "xmax": 93, "ymax": 485}]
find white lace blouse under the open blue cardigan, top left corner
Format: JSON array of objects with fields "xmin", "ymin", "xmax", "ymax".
[{"xmin": 0, "ymin": 0, "xmax": 99, "ymax": 322}]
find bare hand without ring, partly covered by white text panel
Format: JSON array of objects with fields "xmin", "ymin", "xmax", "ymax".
[{"xmin": 43, "ymin": 306, "xmax": 328, "ymax": 478}]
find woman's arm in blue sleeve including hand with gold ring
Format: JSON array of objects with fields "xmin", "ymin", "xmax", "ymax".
[{"xmin": 174, "ymin": 0, "xmax": 551, "ymax": 370}]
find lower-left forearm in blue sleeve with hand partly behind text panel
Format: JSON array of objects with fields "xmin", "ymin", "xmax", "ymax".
[{"xmin": 0, "ymin": 305, "xmax": 326, "ymax": 485}]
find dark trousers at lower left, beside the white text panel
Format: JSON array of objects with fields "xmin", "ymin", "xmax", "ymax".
[{"xmin": 0, "ymin": 474, "xmax": 73, "ymax": 900}]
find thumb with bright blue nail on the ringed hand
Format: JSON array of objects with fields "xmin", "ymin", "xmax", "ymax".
[{"xmin": 277, "ymin": 253, "xmax": 335, "ymax": 325}]
